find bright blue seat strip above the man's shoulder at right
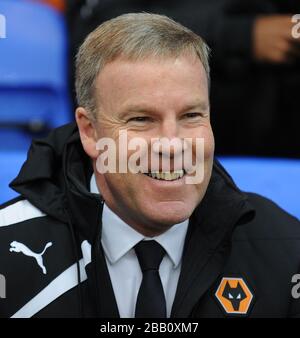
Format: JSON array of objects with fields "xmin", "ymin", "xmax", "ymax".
[{"xmin": 219, "ymin": 157, "xmax": 300, "ymax": 219}]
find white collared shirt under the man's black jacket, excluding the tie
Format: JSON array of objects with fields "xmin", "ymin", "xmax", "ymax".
[{"xmin": 90, "ymin": 175, "xmax": 188, "ymax": 318}]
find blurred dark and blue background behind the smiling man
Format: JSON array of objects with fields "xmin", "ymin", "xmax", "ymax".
[{"xmin": 0, "ymin": 0, "xmax": 300, "ymax": 218}]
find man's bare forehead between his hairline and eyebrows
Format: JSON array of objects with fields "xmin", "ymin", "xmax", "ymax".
[{"xmin": 95, "ymin": 55, "xmax": 208, "ymax": 111}]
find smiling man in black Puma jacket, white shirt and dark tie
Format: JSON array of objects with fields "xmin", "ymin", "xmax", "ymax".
[{"xmin": 0, "ymin": 14, "xmax": 300, "ymax": 318}]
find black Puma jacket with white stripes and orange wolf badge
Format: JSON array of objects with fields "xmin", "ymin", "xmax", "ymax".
[{"xmin": 0, "ymin": 124, "xmax": 300, "ymax": 317}]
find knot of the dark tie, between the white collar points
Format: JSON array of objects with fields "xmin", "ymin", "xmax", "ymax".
[{"xmin": 134, "ymin": 241, "xmax": 166, "ymax": 272}]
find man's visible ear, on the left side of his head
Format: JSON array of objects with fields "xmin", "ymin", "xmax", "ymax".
[{"xmin": 75, "ymin": 107, "xmax": 99, "ymax": 159}]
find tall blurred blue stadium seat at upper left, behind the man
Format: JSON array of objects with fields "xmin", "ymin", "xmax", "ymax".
[{"xmin": 0, "ymin": 0, "xmax": 70, "ymax": 151}]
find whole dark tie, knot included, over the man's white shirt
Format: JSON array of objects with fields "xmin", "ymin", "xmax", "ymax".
[{"xmin": 135, "ymin": 241, "xmax": 166, "ymax": 318}]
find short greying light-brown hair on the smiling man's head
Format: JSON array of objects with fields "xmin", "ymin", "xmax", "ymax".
[{"xmin": 75, "ymin": 13, "xmax": 210, "ymax": 118}]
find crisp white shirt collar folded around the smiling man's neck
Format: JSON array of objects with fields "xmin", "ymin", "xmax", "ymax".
[{"xmin": 90, "ymin": 175, "xmax": 189, "ymax": 269}]
